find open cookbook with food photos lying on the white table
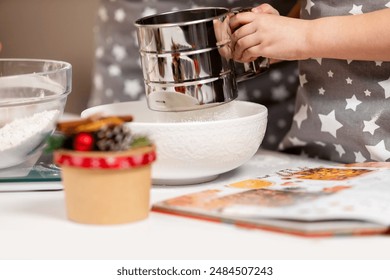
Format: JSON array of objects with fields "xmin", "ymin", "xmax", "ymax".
[{"xmin": 153, "ymin": 162, "xmax": 390, "ymax": 237}]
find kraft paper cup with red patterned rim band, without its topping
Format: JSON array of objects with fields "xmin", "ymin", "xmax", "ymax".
[{"xmin": 54, "ymin": 146, "xmax": 156, "ymax": 225}]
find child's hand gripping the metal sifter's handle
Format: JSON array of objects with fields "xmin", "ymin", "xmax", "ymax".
[{"xmin": 230, "ymin": 4, "xmax": 307, "ymax": 62}]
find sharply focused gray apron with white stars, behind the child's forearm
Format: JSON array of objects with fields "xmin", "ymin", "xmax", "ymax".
[{"xmin": 280, "ymin": 0, "xmax": 390, "ymax": 162}]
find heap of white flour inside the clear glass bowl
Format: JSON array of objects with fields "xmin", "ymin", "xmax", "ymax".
[{"xmin": 0, "ymin": 110, "xmax": 60, "ymax": 168}]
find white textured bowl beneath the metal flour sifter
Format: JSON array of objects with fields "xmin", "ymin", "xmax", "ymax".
[{"xmin": 81, "ymin": 101, "xmax": 267, "ymax": 185}]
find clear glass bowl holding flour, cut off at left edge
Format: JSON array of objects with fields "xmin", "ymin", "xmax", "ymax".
[{"xmin": 0, "ymin": 59, "xmax": 72, "ymax": 170}]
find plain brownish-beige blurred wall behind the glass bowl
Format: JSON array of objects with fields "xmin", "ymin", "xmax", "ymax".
[{"xmin": 0, "ymin": 0, "xmax": 99, "ymax": 114}]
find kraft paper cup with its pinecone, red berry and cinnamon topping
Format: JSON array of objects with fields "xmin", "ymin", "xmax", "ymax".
[{"xmin": 47, "ymin": 116, "xmax": 156, "ymax": 224}]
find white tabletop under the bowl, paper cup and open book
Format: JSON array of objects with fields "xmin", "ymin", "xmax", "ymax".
[{"xmin": 0, "ymin": 150, "xmax": 390, "ymax": 259}]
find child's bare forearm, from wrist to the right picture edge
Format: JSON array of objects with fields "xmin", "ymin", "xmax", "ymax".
[{"xmin": 304, "ymin": 9, "xmax": 390, "ymax": 61}]
